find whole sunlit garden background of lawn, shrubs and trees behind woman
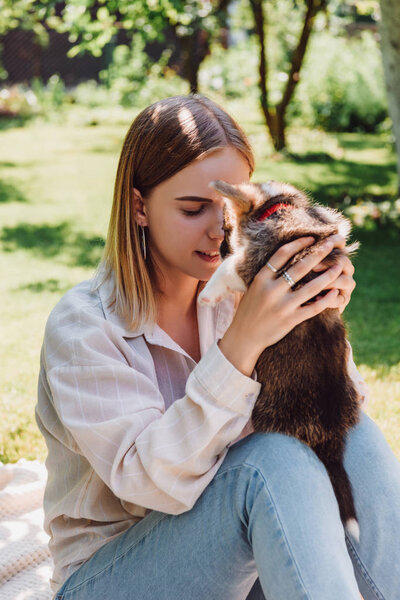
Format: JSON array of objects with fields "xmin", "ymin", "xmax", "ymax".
[{"xmin": 0, "ymin": 0, "xmax": 400, "ymax": 463}]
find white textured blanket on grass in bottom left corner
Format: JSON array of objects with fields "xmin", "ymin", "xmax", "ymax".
[{"xmin": 0, "ymin": 459, "xmax": 53, "ymax": 600}]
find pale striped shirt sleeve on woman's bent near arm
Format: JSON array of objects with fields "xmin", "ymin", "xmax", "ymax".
[{"xmin": 44, "ymin": 300, "xmax": 261, "ymax": 514}]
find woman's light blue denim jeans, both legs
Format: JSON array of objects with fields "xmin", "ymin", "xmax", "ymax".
[{"xmin": 56, "ymin": 414, "xmax": 400, "ymax": 600}]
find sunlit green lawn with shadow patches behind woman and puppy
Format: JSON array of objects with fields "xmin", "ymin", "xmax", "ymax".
[{"xmin": 0, "ymin": 102, "xmax": 400, "ymax": 462}]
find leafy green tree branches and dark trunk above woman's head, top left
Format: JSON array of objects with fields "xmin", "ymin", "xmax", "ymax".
[{"xmin": 0, "ymin": 0, "xmax": 230, "ymax": 92}]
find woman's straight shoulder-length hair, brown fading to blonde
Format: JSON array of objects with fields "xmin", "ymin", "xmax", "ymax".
[{"xmin": 93, "ymin": 94, "xmax": 254, "ymax": 331}]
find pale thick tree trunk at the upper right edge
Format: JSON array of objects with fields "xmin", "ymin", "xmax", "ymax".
[{"xmin": 380, "ymin": 0, "xmax": 400, "ymax": 196}]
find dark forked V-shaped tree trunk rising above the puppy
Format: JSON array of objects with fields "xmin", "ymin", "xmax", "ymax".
[{"xmin": 250, "ymin": 0, "xmax": 327, "ymax": 151}]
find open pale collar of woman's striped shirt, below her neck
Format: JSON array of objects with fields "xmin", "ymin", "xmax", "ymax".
[{"xmin": 98, "ymin": 277, "xmax": 235, "ymax": 360}]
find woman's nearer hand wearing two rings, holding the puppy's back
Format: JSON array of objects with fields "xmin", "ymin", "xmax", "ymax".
[{"xmin": 219, "ymin": 236, "xmax": 351, "ymax": 375}]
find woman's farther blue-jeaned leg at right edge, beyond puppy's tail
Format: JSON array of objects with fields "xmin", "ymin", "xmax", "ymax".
[{"xmin": 344, "ymin": 413, "xmax": 400, "ymax": 600}]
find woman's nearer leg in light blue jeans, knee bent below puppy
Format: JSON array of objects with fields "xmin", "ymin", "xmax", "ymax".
[{"xmin": 57, "ymin": 433, "xmax": 359, "ymax": 600}]
